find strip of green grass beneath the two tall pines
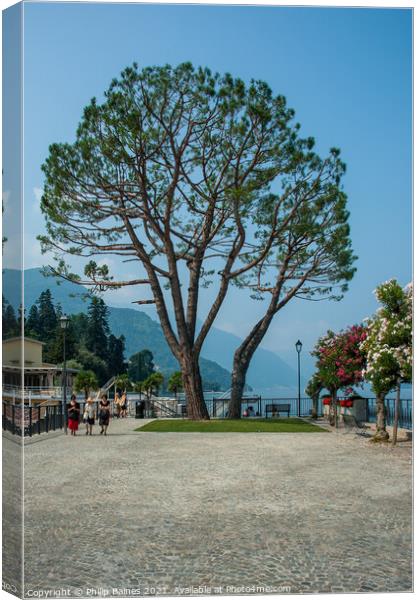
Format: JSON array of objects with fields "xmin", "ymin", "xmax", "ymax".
[{"xmin": 136, "ymin": 418, "xmax": 326, "ymax": 433}]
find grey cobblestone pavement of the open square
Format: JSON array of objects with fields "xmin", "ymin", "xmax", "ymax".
[{"xmin": 18, "ymin": 419, "xmax": 412, "ymax": 596}]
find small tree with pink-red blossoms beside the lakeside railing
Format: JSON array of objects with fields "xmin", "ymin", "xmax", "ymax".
[{"xmin": 312, "ymin": 325, "xmax": 367, "ymax": 426}]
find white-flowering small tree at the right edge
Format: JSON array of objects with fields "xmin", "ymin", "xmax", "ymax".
[{"xmin": 362, "ymin": 279, "xmax": 413, "ymax": 444}]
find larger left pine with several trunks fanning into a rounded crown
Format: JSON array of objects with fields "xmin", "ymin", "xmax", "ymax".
[{"xmin": 40, "ymin": 63, "xmax": 324, "ymax": 419}]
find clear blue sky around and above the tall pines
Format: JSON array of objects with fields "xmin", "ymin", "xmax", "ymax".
[{"xmin": 4, "ymin": 3, "xmax": 412, "ymax": 376}]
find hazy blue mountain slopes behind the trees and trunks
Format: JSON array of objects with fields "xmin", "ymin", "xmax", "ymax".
[{"xmin": 3, "ymin": 269, "xmax": 296, "ymax": 390}]
